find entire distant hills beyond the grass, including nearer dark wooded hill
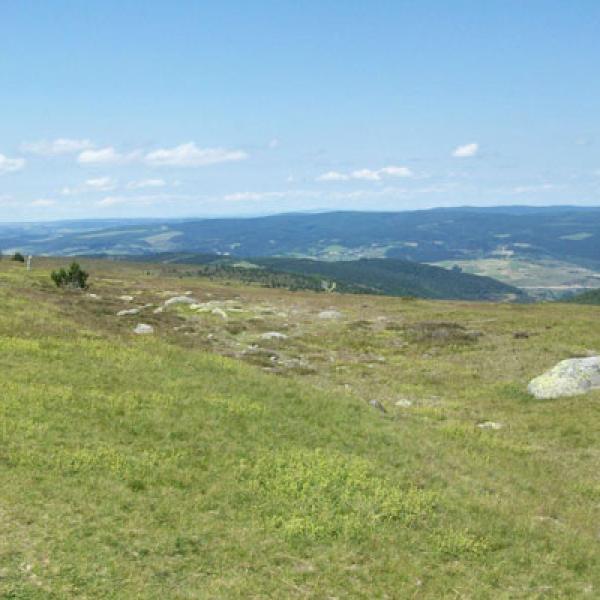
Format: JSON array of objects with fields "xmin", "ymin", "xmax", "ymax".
[{"xmin": 0, "ymin": 206, "xmax": 600, "ymax": 299}]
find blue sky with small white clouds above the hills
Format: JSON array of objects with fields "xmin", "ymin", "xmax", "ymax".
[{"xmin": 0, "ymin": 0, "xmax": 600, "ymax": 221}]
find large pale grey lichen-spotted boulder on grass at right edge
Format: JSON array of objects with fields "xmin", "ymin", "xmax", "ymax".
[{"xmin": 527, "ymin": 356, "xmax": 600, "ymax": 400}]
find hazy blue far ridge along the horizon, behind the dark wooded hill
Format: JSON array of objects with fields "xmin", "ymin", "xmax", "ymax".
[{"xmin": 0, "ymin": 207, "xmax": 600, "ymax": 268}]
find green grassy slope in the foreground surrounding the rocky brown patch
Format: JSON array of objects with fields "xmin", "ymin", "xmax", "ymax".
[{"xmin": 0, "ymin": 262, "xmax": 600, "ymax": 598}]
